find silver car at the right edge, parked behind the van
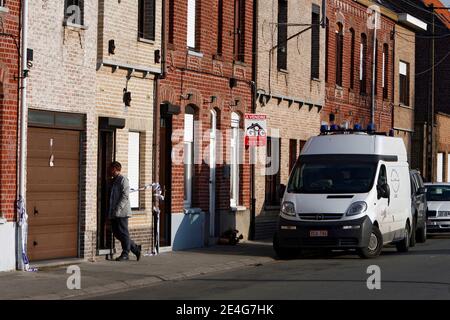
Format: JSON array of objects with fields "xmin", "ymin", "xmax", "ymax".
[{"xmin": 425, "ymin": 183, "xmax": 450, "ymax": 233}]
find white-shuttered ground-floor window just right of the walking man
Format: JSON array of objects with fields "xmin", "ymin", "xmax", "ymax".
[{"xmin": 128, "ymin": 131, "xmax": 141, "ymax": 209}]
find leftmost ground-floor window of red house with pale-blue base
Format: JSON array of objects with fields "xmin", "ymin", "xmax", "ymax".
[{"xmin": 184, "ymin": 106, "xmax": 195, "ymax": 209}]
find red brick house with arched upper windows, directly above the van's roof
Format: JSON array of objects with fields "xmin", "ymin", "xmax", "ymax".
[{"xmin": 322, "ymin": 0, "xmax": 396, "ymax": 131}]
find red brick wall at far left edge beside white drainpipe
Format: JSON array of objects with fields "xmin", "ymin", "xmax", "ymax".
[{"xmin": 0, "ymin": 0, "xmax": 20, "ymax": 221}]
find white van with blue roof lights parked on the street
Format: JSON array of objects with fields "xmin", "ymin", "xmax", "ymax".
[{"xmin": 273, "ymin": 131, "xmax": 412, "ymax": 258}]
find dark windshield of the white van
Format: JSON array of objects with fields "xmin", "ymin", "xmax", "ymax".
[{"xmin": 288, "ymin": 159, "xmax": 377, "ymax": 194}]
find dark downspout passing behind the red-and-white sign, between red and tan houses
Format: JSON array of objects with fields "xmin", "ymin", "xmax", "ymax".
[{"xmin": 249, "ymin": 1, "xmax": 258, "ymax": 240}]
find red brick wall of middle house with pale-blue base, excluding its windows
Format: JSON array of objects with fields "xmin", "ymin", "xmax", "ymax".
[{"xmin": 156, "ymin": 0, "xmax": 253, "ymax": 213}]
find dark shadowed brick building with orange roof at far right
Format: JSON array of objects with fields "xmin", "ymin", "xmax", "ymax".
[{"xmin": 389, "ymin": 0, "xmax": 450, "ymax": 181}]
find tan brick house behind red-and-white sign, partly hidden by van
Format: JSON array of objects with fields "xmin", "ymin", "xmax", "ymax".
[{"xmin": 254, "ymin": 0, "xmax": 325, "ymax": 238}]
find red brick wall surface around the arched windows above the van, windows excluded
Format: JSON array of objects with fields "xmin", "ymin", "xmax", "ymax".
[{"xmin": 322, "ymin": 0, "xmax": 395, "ymax": 131}]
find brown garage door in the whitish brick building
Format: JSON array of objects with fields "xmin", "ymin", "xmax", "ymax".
[{"xmin": 27, "ymin": 128, "xmax": 80, "ymax": 261}]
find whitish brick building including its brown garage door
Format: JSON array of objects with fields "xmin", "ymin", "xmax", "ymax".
[{"xmin": 26, "ymin": 0, "xmax": 98, "ymax": 261}]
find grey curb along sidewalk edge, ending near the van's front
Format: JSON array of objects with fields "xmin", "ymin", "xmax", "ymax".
[{"xmin": 20, "ymin": 257, "xmax": 276, "ymax": 300}]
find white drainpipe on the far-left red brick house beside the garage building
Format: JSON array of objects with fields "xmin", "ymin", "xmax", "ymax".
[{"xmin": 16, "ymin": 0, "xmax": 28, "ymax": 271}]
